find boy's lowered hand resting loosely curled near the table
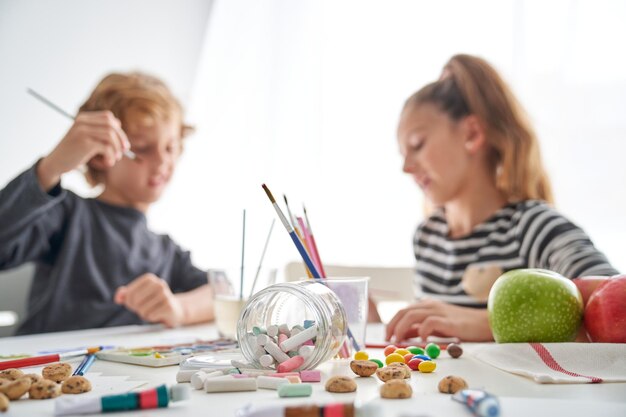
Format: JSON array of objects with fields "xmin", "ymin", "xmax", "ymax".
[{"xmin": 114, "ymin": 273, "xmax": 185, "ymax": 327}]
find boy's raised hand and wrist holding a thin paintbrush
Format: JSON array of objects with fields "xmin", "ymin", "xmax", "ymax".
[{"xmin": 37, "ymin": 111, "xmax": 130, "ymax": 191}]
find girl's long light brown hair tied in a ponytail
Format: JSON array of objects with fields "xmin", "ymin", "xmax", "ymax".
[{"xmin": 404, "ymin": 55, "xmax": 554, "ymax": 203}]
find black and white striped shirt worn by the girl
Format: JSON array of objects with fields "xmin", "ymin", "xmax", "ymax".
[{"xmin": 413, "ymin": 200, "xmax": 618, "ymax": 308}]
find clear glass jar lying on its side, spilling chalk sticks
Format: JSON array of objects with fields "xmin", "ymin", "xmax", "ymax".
[{"xmin": 237, "ymin": 280, "xmax": 348, "ymax": 371}]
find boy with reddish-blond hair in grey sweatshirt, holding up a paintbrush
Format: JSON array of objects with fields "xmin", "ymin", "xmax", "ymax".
[{"xmin": 0, "ymin": 73, "xmax": 213, "ymax": 334}]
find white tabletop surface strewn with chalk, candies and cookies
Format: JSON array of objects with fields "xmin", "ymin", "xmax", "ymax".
[{"xmin": 0, "ymin": 325, "xmax": 626, "ymax": 417}]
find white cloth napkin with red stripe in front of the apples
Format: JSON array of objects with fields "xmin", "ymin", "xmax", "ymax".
[{"xmin": 474, "ymin": 343, "xmax": 626, "ymax": 384}]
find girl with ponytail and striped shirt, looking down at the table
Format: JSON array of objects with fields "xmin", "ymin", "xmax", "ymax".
[{"xmin": 387, "ymin": 55, "xmax": 617, "ymax": 341}]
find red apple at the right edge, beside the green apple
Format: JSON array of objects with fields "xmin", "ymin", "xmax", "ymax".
[{"xmin": 584, "ymin": 275, "xmax": 626, "ymax": 343}]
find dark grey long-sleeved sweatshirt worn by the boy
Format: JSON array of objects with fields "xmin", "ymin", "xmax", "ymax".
[{"xmin": 0, "ymin": 162, "xmax": 207, "ymax": 334}]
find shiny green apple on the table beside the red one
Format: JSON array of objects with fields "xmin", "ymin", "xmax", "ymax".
[{"xmin": 487, "ymin": 269, "xmax": 583, "ymax": 343}]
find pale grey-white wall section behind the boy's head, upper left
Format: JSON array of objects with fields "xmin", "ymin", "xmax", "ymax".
[{"xmin": 0, "ymin": 0, "xmax": 211, "ymax": 192}]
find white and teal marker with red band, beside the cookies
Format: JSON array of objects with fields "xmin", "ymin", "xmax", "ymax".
[{"xmin": 54, "ymin": 384, "xmax": 190, "ymax": 416}]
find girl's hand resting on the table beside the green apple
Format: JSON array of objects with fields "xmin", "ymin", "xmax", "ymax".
[{"xmin": 386, "ymin": 299, "xmax": 493, "ymax": 342}]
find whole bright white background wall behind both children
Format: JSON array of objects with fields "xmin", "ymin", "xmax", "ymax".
[{"xmin": 0, "ymin": 0, "xmax": 626, "ymax": 280}]
